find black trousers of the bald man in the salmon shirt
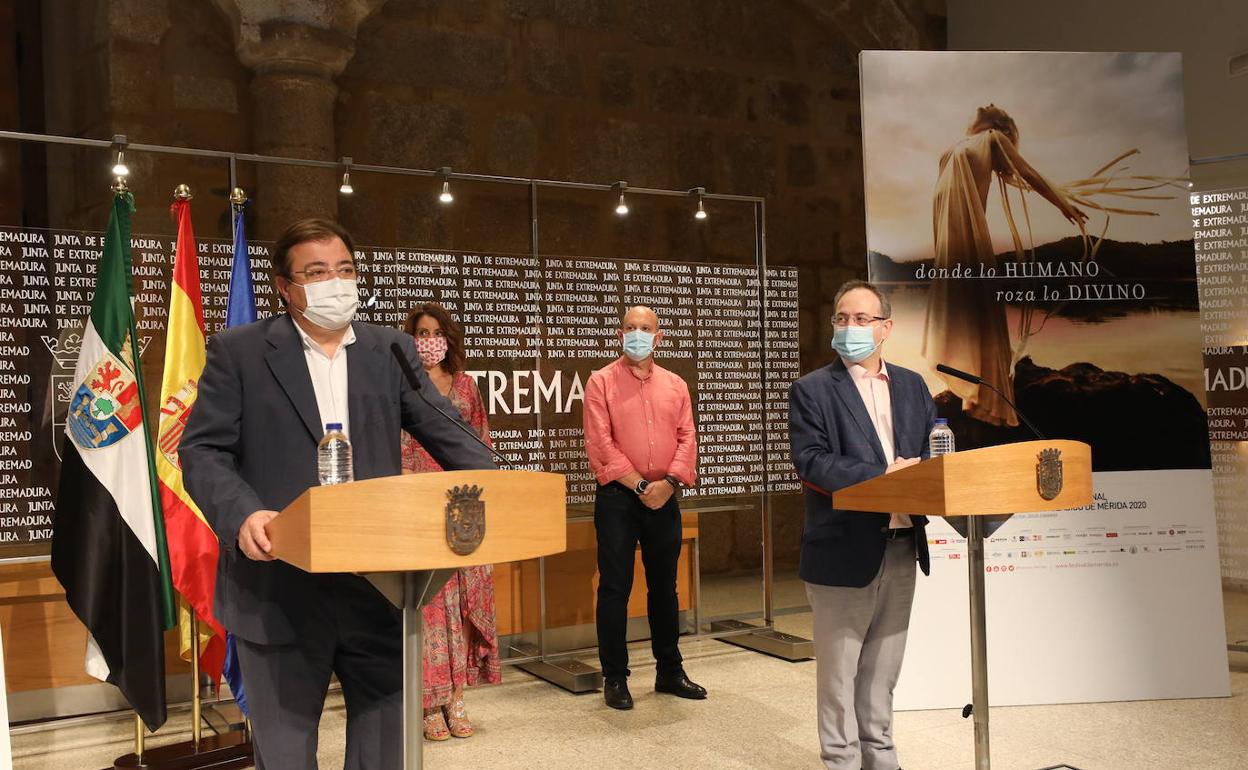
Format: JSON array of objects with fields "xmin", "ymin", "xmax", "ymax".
[{"xmin": 594, "ymin": 483, "xmax": 680, "ymax": 679}]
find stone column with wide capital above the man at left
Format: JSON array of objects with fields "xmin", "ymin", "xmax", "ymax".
[{"xmin": 238, "ymin": 21, "xmax": 354, "ymax": 238}]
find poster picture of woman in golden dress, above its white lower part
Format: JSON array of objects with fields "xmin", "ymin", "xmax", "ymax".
[{"xmin": 861, "ymin": 51, "xmax": 1209, "ymax": 470}]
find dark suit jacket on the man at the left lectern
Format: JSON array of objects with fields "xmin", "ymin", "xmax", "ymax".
[{"xmin": 178, "ymin": 314, "xmax": 494, "ymax": 644}]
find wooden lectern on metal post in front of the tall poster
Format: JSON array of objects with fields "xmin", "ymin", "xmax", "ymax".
[{"xmin": 832, "ymin": 441, "xmax": 1092, "ymax": 770}]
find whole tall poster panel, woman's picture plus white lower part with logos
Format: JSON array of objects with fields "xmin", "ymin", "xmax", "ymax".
[{"xmin": 861, "ymin": 51, "xmax": 1229, "ymax": 709}]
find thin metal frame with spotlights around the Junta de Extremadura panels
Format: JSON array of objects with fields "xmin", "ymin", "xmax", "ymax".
[{"xmin": 0, "ymin": 131, "xmax": 793, "ymax": 698}]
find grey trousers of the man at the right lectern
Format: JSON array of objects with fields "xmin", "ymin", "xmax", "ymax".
[{"xmin": 806, "ymin": 538, "xmax": 916, "ymax": 770}]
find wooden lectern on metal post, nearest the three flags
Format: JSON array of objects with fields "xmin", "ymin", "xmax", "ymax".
[{"xmin": 266, "ymin": 470, "xmax": 568, "ymax": 770}]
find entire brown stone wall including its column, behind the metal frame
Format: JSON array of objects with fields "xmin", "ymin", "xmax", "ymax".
[{"xmin": 17, "ymin": 0, "xmax": 945, "ymax": 570}]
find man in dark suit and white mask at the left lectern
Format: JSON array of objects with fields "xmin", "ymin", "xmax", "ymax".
[{"xmin": 178, "ymin": 220, "xmax": 494, "ymax": 770}]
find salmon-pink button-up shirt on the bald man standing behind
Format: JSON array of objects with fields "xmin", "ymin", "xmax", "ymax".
[{"xmin": 585, "ymin": 357, "xmax": 698, "ymax": 487}]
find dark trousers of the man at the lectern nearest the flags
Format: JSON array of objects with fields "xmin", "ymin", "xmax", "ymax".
[{"xmin": 238, "ymin": 574, "xmax": 403, "ymax": 770}]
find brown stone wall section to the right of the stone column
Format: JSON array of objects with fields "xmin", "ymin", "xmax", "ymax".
[{"xmin": 337, "ymin": 0, "xmax": 943, "ymax": 381}]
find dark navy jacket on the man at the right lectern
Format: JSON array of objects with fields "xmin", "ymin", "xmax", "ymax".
[{"xmin": 789, "ymin": 358, "xmax": 936, "ymax": 588}]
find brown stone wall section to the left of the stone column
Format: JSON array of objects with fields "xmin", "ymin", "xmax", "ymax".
[{"xmin": 34, "ymin": 0, "xmax": 251, "ymax": 232}]
